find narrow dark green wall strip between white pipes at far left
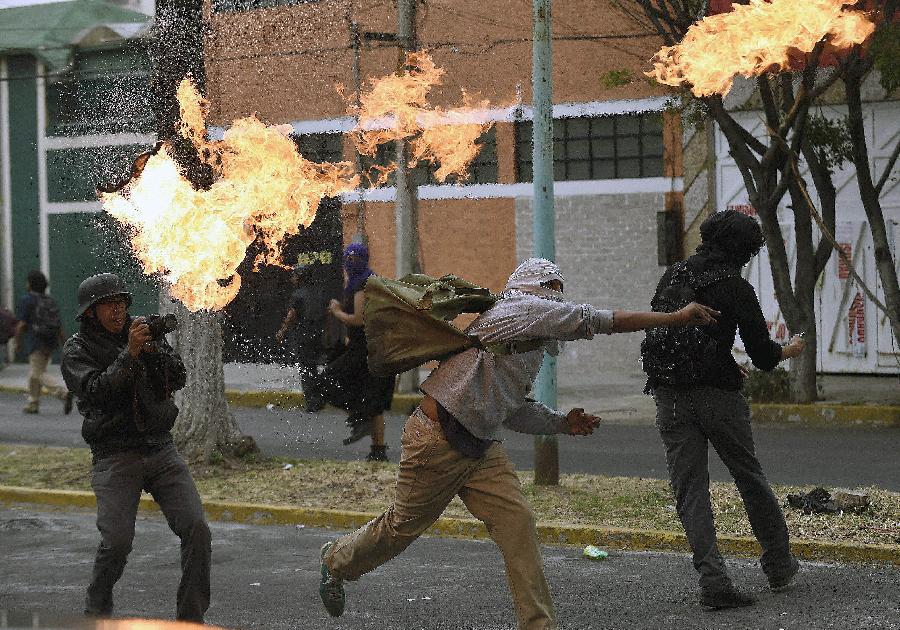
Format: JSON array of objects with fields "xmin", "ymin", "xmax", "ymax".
[{"xmin": 6, "ymin": 55, "xmax": 40, "ymax": 301}]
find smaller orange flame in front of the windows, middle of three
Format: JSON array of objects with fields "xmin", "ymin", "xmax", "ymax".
[{"xmin": 354, "ymin": 51, "xmax": 493, "ymax": 185}]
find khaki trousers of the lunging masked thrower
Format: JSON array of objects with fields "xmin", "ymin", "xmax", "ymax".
[{"xmin": 325, "ymin": 408, "xmax": 557, "ymax": 630}]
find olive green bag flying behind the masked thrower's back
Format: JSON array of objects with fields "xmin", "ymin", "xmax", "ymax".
[{"xmin": 364, "ymin": 274, "xmax": 543, "ymax": 376}]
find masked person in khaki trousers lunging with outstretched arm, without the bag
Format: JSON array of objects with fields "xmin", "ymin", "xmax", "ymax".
[{"xmin": 319, "ymin": 258, "xmax": 716, "ymax": 630}]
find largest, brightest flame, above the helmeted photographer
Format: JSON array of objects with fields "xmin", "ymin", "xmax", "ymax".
[{"xmin": 100, "ymin": 79, "xmax": 359, "ymax": 311}]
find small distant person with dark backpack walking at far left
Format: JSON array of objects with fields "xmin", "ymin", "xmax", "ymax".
[{"xmin": 13, "ymin": 269, "xmax": 73, "ymax": 415}]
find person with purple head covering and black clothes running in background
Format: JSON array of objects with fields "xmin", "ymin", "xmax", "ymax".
[{"xmin": 318, "ymin": 243, "xmax": 395, "ymax": 461}]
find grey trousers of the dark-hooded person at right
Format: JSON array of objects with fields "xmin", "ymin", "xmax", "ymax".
[{"xmin": 654, "ymin": 387, "xmax": 791, "ymax": 591}]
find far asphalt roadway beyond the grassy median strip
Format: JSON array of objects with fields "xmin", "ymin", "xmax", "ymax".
[{"xmin": 0, "ymin": 393, "xmax": 900, "ymax": 492}]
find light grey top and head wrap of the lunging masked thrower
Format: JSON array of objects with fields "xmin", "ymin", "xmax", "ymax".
[{"xmin": 421, "ymin": 258, "xmax": 613, "ymax": 439}]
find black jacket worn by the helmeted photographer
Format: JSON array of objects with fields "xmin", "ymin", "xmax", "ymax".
[{"xmin": 62, "ymin": 318, "xmax": 186, "ymax": 458}]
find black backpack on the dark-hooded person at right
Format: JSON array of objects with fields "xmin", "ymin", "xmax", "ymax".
[{"xmin": 641, "ymin": 261, "xmax": 740, "ymax": 387}]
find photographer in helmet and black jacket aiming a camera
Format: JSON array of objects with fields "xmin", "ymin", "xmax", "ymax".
[{"xmin": 62, "ymin": 273, "xmax": 211, "ymax": 623}]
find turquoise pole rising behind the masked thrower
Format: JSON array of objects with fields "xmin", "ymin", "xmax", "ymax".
[{"xmin": 531, "ymin": 0, "xmax": 559, "ymax": 486}]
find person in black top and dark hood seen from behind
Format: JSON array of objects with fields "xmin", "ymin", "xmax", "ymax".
[{"xmin": 641, "ymin": 210, "xmax": 805, "ymax": 608}]
